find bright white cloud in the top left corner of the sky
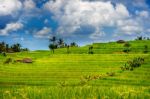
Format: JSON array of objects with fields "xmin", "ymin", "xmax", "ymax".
[{"xmin": 0, "ymin": 0, "xmax": 22, "ymax": 16}]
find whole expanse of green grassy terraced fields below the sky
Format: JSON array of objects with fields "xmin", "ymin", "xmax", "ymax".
[{"xmin": 0, "ymin": 40, "xmax": 150, "ymax": 99}]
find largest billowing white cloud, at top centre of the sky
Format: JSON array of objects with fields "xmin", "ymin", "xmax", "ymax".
[{"xmin": 44, "ymin": 0, "xmax": 130, "ymax": 39}]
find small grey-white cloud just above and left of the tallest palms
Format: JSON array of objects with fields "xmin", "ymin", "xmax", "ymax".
[{"xmin": 34, "ymin": 27, "xmax": 52, "ymax": 38}]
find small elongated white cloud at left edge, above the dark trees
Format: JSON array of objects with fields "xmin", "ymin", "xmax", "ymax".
[{"xmin": 0, "ymin": 22, "xmax": 23, "ymax": 36}]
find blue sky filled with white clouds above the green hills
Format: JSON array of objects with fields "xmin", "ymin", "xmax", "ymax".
[{"xmin": 0, "ymin": 0, "xmax": 150, "ymax": 50}]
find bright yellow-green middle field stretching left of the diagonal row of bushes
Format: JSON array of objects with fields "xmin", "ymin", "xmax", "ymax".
[{"xmin": 0, "ymin": 52, "xmax": 148, "ymax": 85}]
